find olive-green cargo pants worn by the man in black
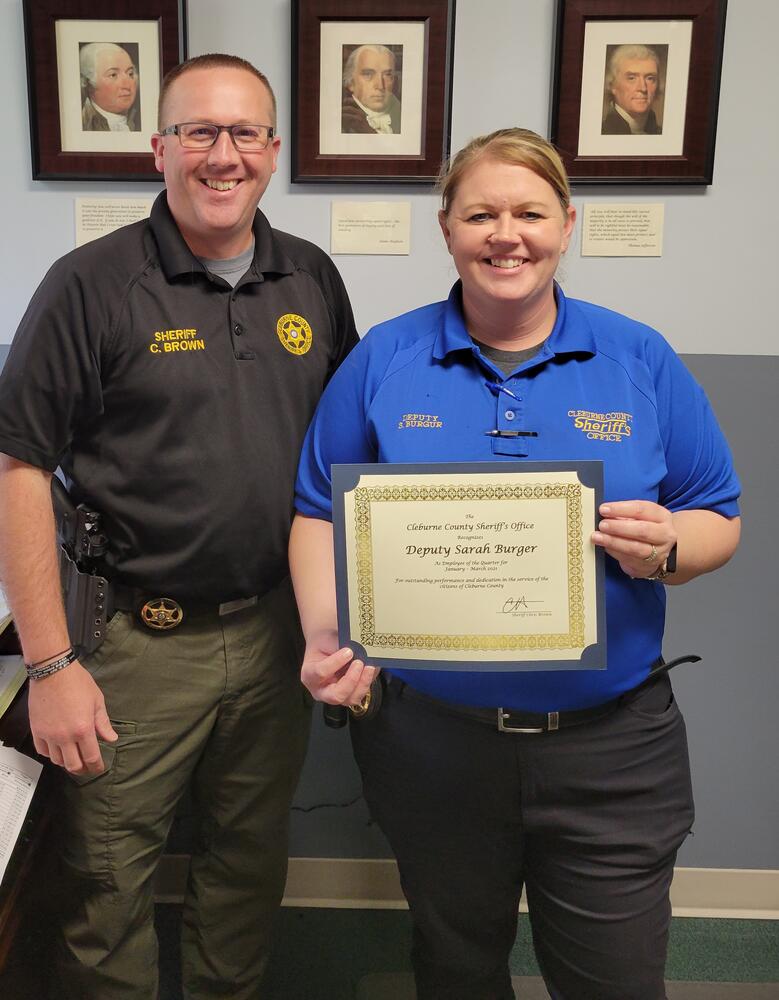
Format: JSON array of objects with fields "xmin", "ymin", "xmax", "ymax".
[{"xmin": 55, "ymin": 580, "xmax": 310, "ymax": 1000}]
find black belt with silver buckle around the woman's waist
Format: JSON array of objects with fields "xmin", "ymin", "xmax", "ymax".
[{"xmin": 387, "ymin": 654, "xmax": 701, "ymax": 734}]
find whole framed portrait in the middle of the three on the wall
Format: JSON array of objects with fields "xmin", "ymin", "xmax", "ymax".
[{"xmin": 292, "ymin": 0, "xmax": 454, "ymax": 183}]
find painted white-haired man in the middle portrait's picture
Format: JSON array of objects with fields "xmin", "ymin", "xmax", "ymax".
[{"xmin": 341, "ymin": 45, "xmax": 400, "ymax": 135}]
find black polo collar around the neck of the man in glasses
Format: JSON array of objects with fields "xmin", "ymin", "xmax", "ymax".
[{"xmin": 149, "ymin": 191, "xmax": 295, "ymax": 280}]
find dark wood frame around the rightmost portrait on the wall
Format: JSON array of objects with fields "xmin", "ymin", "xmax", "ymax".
[{"xmin": 550, "ymin": 0, "xmax": 727, "ymax": 184}]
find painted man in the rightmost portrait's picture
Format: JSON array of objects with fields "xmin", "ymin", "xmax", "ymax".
[{"xmin": 601, "ymin": 45, "xmax": 663, "ymax": 135}]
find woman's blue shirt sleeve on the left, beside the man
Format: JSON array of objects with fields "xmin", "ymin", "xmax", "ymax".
[{"xmin": 295, "ymin": 338, "xmax": 377, "ymax": 521}]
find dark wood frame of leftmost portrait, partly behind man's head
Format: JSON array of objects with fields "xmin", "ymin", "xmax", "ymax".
[{"xmin": 23, "ymin": 0, "xmax": 187, "ymax": 181}]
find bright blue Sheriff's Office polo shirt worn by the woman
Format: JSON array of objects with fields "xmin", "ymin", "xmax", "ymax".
[{"xmin": 296, "ymin": 282, "xmax": 739, "ymax": 712}]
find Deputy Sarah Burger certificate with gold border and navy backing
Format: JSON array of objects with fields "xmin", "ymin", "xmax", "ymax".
[{"xmin": 332, "ymin": 462, "xmax": 606, "ymax": 671}]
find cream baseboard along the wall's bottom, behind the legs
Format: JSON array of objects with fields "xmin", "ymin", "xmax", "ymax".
[{"xmin": 155, "ymin": 854, "xmax": 779, "ymax": 920}]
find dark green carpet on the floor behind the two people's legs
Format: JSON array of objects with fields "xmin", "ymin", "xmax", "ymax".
[{"xmin": 0, "ymin": 906, "xmax": 779, "ymax": 1000}]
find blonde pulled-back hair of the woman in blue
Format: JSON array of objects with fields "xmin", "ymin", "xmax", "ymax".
[{"xmin": 436, "ymin": 128, "xmax": 571, "ymax": 215}]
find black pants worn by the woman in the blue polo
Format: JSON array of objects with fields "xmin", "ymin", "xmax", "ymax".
[{"xmin": 351, "ymin": 674, "xmax": 694, "ymax": 1000}]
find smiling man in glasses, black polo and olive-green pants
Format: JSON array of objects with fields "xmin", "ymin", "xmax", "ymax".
[{"xmin": 0, "ymin": 55, "xmax": 356, "ymax": 1000}]
